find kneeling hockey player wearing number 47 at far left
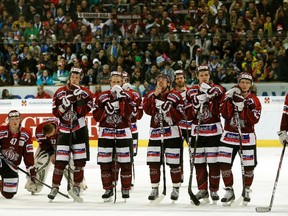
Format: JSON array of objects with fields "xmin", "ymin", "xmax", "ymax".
[{"xmin": 0, "ymin": 110, "xmax": 36, "ymax": 199}]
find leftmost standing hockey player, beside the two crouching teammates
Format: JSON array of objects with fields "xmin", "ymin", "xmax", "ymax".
[{"xmin": 48, "ymin": 67, "xmax": 94, "ymax": 202}]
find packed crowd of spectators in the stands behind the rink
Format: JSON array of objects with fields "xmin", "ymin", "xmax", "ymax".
[{"xmin": 0, "ymin": 0, "xmax": 288, "ymax": 96}]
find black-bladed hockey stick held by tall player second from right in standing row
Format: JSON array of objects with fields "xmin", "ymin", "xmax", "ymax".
[{"xmin": 187, "ymin": 104, "xmax": 203, "ymax": 206}]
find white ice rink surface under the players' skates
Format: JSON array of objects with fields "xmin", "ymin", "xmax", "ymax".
[{"xmin": 0, "ymin": 147, "xmax": 288, "ymax": 216}]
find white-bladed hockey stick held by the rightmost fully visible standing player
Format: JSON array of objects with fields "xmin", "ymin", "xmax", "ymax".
[{"xmin": 233, "ymin": 107, "xmax": 245, "ymax": 206}]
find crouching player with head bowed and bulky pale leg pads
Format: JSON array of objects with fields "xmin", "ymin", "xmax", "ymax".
[{"xmin": 25, "ymin": 118, "xmax": 58, "ymax": 194}]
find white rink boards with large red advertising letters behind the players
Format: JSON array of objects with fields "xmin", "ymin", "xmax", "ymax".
[{"xmin": 0, "ymin": 96, "xmax": 285, "ymax": 147}]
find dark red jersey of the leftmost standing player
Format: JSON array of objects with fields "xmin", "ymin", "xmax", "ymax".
[{"xmin": 52, "ymin": 84, "xmax": 93, "ymax": 132}]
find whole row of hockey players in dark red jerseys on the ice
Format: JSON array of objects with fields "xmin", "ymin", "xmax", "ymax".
[{"xmin": 0, "ymin": 65, "xmax": 288, "ymax": 212}]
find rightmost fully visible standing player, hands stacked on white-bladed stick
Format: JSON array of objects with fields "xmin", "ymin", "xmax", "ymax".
[{"xmin": 218, "ymin": 73, "xmax": 261, "ymax": 205}]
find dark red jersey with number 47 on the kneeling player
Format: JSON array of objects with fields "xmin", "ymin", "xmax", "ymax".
[{"xmin": 0, "ymin": 125, "xmax": 34, "ymax": 168}]
